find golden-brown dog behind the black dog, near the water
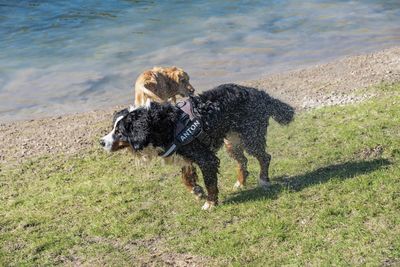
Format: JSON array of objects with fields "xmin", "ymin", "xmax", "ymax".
[{"xmin": 135, "ymin": 67, "xmax": 194, "ymax": 106}]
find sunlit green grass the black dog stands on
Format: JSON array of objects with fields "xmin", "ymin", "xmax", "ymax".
[{"xmin": 0, "ymin": 85, "xmax": 400, "ymax": 266}]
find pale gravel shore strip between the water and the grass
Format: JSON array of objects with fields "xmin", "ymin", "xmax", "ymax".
[{"xmin": 0, "ymin": 46, "xmax": 400, "ymax": 163}]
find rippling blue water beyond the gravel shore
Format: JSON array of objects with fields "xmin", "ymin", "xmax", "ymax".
[{"xmin": 0, "ymin": 0, "xmax": 400, "ymax": 121}]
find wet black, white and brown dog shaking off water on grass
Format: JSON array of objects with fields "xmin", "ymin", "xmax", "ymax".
[{"xmin": 100, "ymin": 84, "xmax": 294, "ymax": 209}]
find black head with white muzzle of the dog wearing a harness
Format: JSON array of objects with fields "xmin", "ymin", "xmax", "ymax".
[{"xmin": 100, "ymin": 102, "xmax": 173, "ymax": 152}]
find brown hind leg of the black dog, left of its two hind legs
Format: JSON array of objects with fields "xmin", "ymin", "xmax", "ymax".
[{"xmin": 224, "ymin": 139, "xmax": 249, "ymax": 188}]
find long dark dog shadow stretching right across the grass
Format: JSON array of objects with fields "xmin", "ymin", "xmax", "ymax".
[{"xmin": 224, "ymin": 159, "xmax": 391, "ymax": 204}]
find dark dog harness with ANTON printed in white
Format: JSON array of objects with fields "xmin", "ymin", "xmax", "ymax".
[{"xmin": 161, "ymin": 98, "xmax": 209, "ymax": 158}]
